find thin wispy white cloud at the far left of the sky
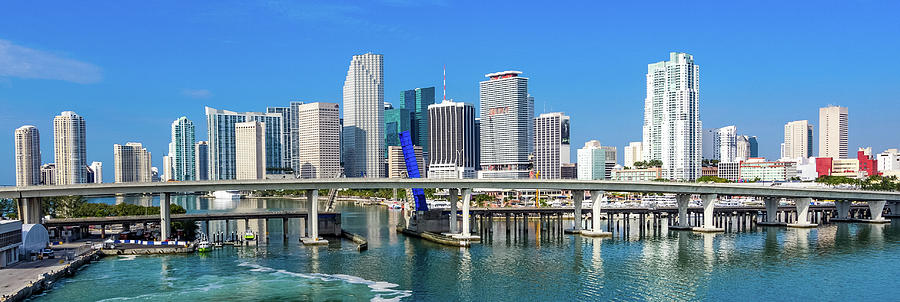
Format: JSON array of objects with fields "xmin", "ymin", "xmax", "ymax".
[{"xmin": 0, "ymin": 40, "xmax": 103, "ymax": 84}]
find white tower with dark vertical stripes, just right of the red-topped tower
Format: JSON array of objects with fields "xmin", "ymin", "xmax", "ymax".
[{"xmin": 533, "ymin": 112, "xmax": 571, "ymax": 179}]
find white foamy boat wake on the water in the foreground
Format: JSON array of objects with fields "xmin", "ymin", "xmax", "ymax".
[{"xmin": 238, "ymin": 262, "xmax": 412, "ymax": 301}]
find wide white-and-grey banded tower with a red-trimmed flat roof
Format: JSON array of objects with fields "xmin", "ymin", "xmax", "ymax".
[{"xmin": 478, "ymin": 71, "xmax": 534, "ymax": 179}]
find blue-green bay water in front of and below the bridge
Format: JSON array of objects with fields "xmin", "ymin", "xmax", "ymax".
[{"xmin": 36, "ymin": 197, "xmax": 900, "ymax": 301}]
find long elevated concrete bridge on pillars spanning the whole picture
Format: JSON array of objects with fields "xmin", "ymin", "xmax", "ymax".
[{"xmin": 0, "ymin": 178, "xmax": 900, "ymax": 243}]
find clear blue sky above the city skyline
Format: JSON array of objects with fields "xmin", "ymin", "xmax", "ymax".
[{"xmin": 0, "ymin": 0, "xmax": 900, "ymax": 184}]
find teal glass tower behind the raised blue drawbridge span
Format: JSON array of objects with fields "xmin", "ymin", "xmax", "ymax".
[{"xmin": 400, "ymin": 87, "xmax": 434, "ymax": 159}]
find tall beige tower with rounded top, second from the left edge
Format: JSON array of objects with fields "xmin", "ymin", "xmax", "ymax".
[{"xmin": 53, "ymin": 111, "xmax": 87, "ymax": 185}]
